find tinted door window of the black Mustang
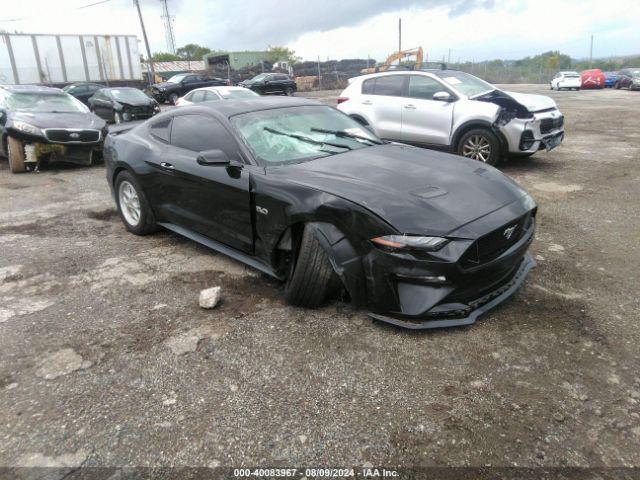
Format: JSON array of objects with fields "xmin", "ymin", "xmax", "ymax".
[{"xmin": 171, "ymin": 115, "xmax": 239, "ymax": 159}]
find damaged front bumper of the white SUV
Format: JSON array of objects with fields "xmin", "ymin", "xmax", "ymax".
[{"xmin": 500, "ymin": 109, "xmax": 564, "ymax": 154}]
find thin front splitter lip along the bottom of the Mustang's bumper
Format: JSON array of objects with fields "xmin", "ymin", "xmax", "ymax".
[{"xmin": 369, "ymin": 253, "xmax": 536, "ymax": 330}]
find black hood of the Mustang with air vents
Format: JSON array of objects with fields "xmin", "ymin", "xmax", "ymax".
[{"xmin": 268, "ymin": 144, "xmax": 526, "ymax": 238}]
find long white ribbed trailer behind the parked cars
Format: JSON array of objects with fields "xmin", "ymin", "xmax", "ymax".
[{"xmin": 0, "ymin": 33, "xmax": 142, "ymax": 85}]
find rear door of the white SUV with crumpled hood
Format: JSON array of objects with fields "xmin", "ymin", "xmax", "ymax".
[{"xmin": 358, "ymin": 75, "xmax": 408, "ymax": 140}]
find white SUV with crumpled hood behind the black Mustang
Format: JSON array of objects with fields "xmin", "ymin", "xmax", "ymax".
[{"xmin": 338, "ymin": 70, "xmax": 564, "ymax": 165}]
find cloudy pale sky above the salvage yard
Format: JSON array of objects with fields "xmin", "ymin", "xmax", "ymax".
[{"xmin": 0, "ymin": 0, "xmax": 640, "ymax": 62}]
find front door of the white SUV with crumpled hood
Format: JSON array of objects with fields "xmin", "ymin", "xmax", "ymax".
[{"xmin": 402, "ymin": 75, "xmax": 456, "ymax": 146}]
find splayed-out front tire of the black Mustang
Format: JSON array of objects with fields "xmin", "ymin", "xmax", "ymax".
[{"xmin": 284, "ymin": 226, "xmax": 340, "ymax": 308}]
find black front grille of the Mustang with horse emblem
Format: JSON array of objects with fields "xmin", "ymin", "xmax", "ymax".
[{"xmin": 460, "ymin": 212, "xmax": 533, "ymax": 268}]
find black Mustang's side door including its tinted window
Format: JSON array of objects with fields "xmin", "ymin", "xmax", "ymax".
[{"xmin": 156, "ymin": 114, "xmax": 253, "ymax": 253}]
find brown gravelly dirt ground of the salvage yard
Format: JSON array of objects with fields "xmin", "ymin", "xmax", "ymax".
[{"xmin": 0, "ymin": 85, "xmax": 640, "ymax": 467}]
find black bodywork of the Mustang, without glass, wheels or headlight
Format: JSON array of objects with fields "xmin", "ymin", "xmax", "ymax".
[{"xmin": 105, "ymin": 98, "xmax": 537, "ymax": 328}]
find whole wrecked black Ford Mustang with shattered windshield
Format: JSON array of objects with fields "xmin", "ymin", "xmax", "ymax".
[{"xmin": 105, "ymin": 98, "xmax": 536, "ymax": 328}]
